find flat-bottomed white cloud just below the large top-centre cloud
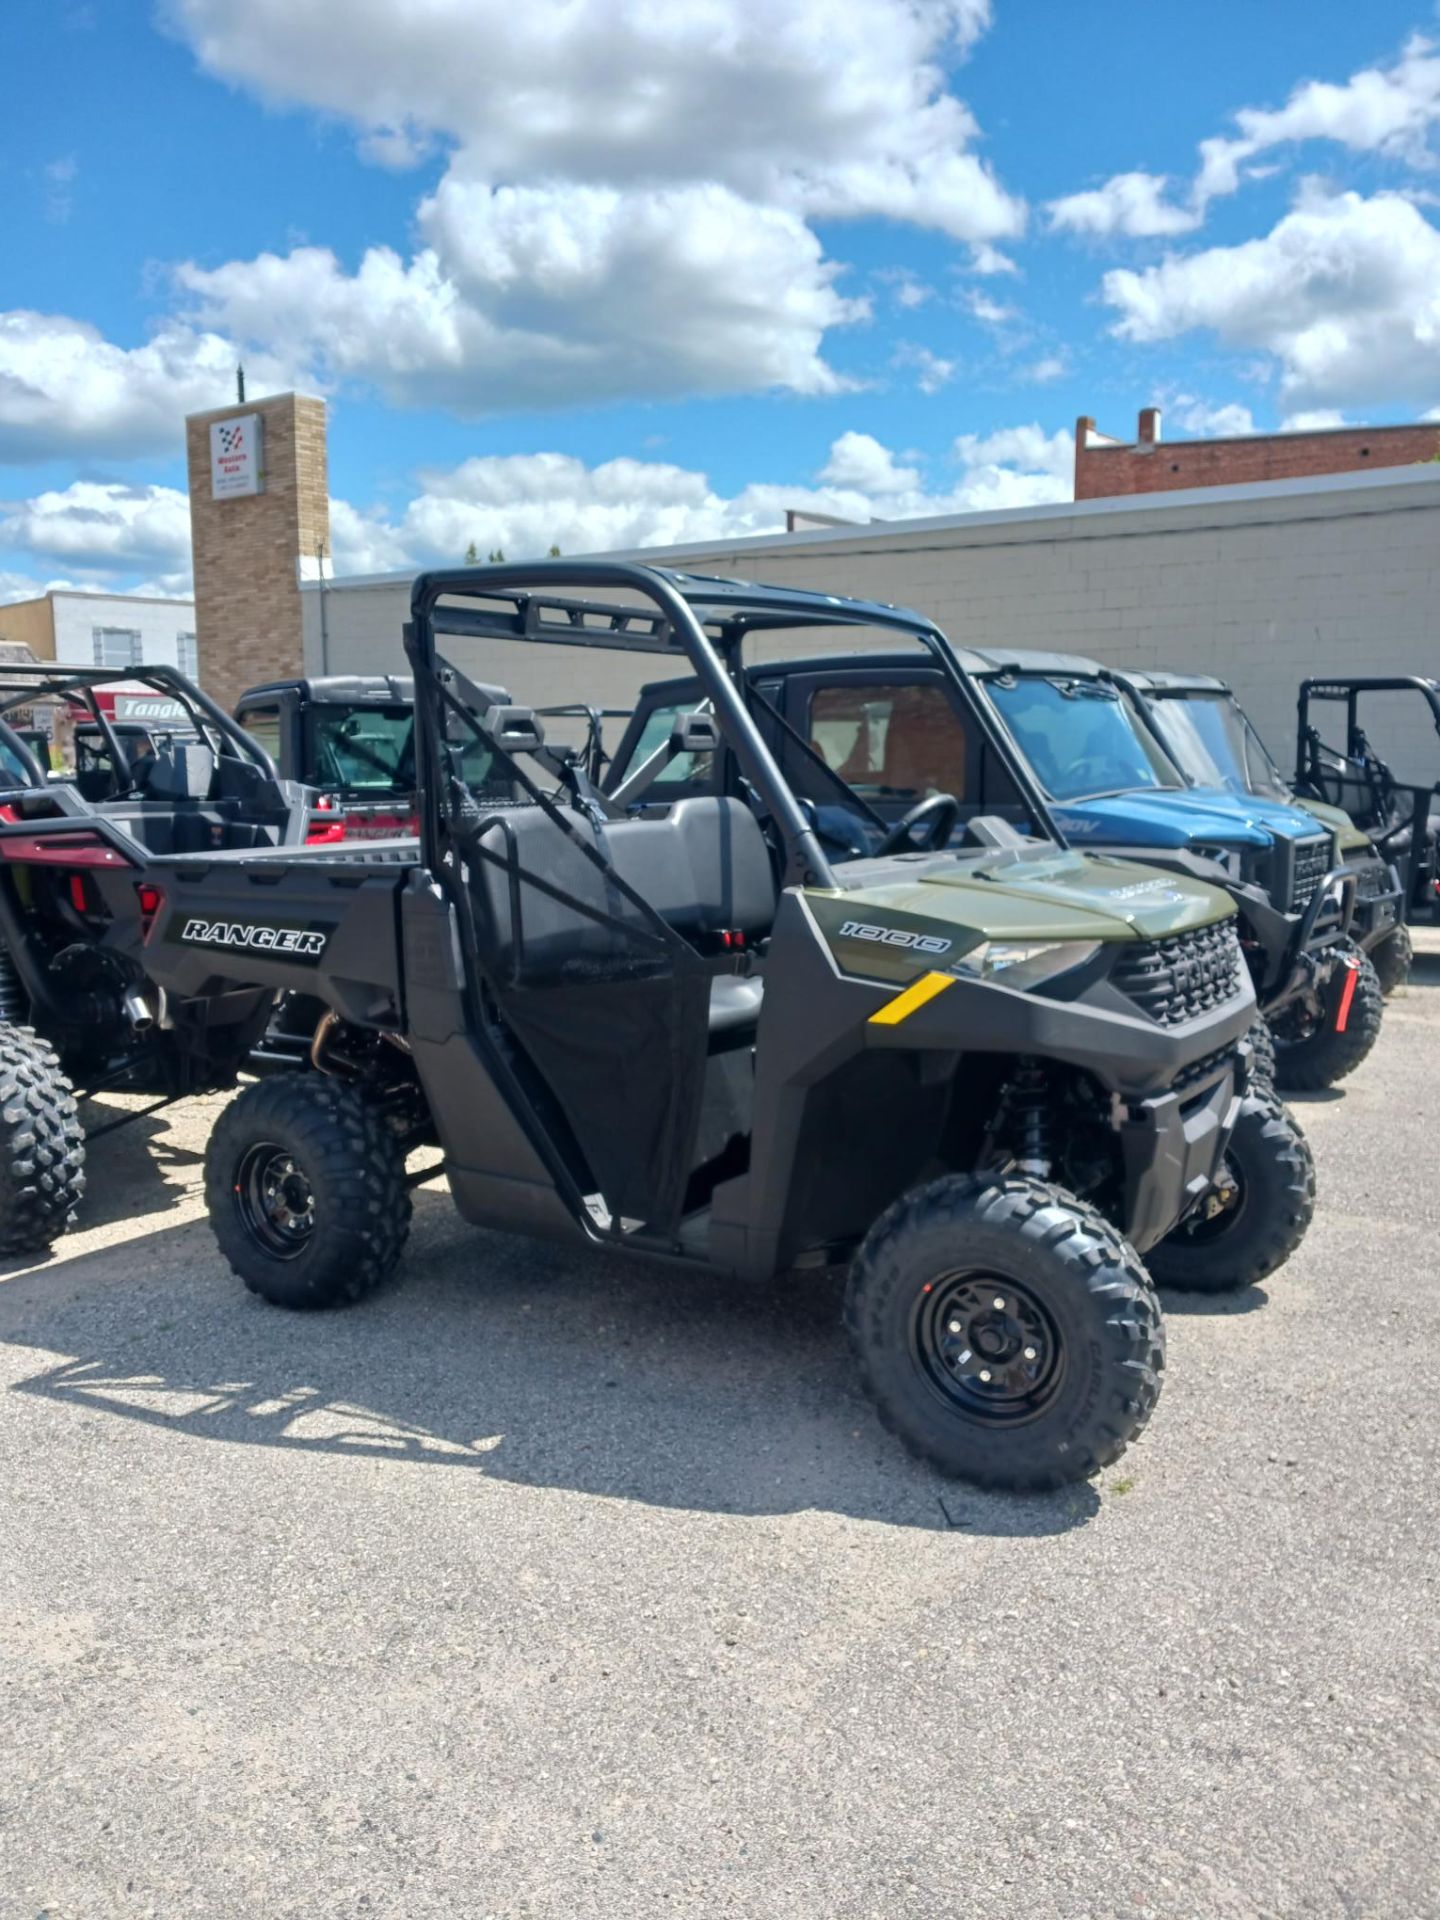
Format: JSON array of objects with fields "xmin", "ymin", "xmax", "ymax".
[{"xmin": 179, "ymin": 177, "xmax": 870, "ymax": 415}]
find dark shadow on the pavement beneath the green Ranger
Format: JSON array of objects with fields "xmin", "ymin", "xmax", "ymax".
[{"xmin": 0, "ymin": 1192, "xmax": 1105, "ymax": 1536}]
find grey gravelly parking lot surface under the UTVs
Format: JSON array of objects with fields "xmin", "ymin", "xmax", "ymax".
[{"xmin": 0, "ymin": 937, "xmax": 1440, "ymax": 1920}]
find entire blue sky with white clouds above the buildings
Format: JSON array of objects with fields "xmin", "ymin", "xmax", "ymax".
[{"xmin": 0, "ymin": 0, "xmax": 1440, "ymax": 597}]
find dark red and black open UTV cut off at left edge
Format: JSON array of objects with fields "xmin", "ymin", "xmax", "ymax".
[{"xmin": 0, "ymin": 664, "xmax": 307, "ymax": 1254}]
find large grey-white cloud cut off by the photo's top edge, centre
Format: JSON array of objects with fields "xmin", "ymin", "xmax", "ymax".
[{"xmin": 165, "ymin": 0, "xmax": 1020, "ymax": 240}]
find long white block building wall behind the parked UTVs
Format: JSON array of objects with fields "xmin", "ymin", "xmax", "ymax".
[{"xmin": 305, "ymin": 465, "xmax": 1440, "ymax": 780}]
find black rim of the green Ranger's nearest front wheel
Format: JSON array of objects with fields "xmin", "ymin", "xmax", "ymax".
[{"xmin": 910, "ymin": 1273, "xmax": 1066, "ymax": 1427}]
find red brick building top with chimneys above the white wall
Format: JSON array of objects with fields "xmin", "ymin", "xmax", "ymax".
[{"xmin": 1075, "ymin": 407, "xmax": 1440, "ymax": 499}]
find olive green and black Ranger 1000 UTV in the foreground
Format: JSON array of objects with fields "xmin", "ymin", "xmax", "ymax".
[{"xmin": 121, "ymin": 561, "xmax": 1313, "ymax": 1488}]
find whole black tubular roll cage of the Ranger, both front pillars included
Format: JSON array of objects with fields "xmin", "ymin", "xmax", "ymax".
[{"xmin": 405, "ymin": 561, "xmax": 1068, "ymax": 891}]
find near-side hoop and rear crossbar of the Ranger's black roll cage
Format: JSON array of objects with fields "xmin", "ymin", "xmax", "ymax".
[{"xmin": 405, "ymin": 561, "xmax": 839, "ymax": 889}]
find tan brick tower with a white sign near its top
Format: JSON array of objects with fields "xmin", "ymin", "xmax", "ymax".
[{"xmin": 184, "ymin": 394, "xmax": 330, "ymax": 707}]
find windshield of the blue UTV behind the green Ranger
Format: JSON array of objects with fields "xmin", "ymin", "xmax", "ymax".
[{"xmin": 985, "ymin": 674, "xmax": 1183, "ymax": 801}]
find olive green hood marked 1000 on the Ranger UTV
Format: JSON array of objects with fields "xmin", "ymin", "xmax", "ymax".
[{"xmin": 804, "ymin": 851, "xmax": 1235, "ymax": 981}]
